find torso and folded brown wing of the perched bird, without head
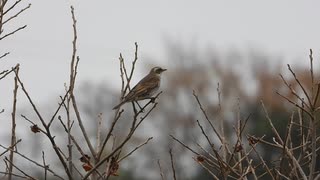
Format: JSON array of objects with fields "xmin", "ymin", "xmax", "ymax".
[{"xmin": 125, "ymin": 76, "xmax": 160, "ymax": 101}]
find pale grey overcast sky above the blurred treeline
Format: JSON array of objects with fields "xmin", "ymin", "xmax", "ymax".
[{"xmin": 0, "ymin": 0, "xmax": 320, "ymax": 114}]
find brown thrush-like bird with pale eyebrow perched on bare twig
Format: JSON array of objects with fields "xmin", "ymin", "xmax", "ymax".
[{"xmin": 113, "ymin": 66, "xmax": 167, "ymax": 109}]
